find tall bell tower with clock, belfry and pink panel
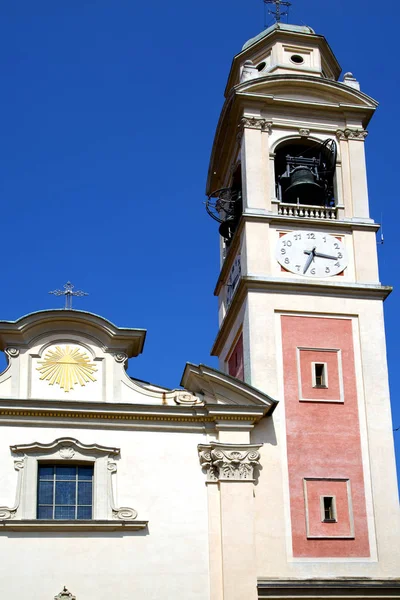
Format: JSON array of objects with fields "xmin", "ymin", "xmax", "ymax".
[{"xmin": 207, "ymin": 23, "xmax": 399, "ymax": 580}]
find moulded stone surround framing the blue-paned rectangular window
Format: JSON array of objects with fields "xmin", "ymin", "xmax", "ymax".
[{"xmin": 0, "ymin": 437, "xmax": 147, "ymax": 531}]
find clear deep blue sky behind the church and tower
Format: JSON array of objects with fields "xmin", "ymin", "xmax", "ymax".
[{"xmin": 0, "ymin": 0, "xmax": 400, "ymax": 482}]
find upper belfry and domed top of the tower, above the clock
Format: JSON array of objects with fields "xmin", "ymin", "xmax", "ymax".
[{"xmin": 207, "ymin": 22, "xmax": 377, "ymax": 236}]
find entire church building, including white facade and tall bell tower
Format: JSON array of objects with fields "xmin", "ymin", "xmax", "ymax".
[{"xmin": 0, "ymin": 23, "xmax": 400, "ymax": 600}]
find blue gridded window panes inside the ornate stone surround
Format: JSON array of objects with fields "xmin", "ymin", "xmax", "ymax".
[{"xmin": 37, "ymin": 463, "xmax": 93, "ymax": 521}]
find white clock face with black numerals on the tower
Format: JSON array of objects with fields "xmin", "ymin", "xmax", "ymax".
[{"xmin": 276, "ymin": 231, "xmax": 348, "ymax": 278}]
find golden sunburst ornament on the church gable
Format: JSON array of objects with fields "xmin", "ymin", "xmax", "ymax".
[{"xmin": 37, "ymin": 346, "xmax": 97, "ymax": 392}]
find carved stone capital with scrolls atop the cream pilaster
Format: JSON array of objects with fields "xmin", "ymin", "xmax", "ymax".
[{"xmin": 198, "ymin": 442, "xmax": 262, "ymax": 482}]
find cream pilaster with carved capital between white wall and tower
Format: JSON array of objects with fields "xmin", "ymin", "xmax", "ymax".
[{"xmin": 198, "ymin": 442, "xmax": 261, "ymax": 600}]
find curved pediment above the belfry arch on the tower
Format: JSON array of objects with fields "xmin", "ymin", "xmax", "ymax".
[{"xmin": 235, "ymin": 75, "xmax": 378, "ymax": 110}]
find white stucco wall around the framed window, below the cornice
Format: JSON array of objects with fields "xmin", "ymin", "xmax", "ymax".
[{"xmin": 0, "ymin": 427, "xmax": 209, "ymax": 600}]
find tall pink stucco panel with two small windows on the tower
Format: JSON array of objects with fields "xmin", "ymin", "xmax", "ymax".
[{"xmin": 281, "ymin": 315, "xmax": 370, "ymax": 557}]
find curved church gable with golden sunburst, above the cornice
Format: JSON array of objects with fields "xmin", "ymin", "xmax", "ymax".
[{"xmin": 0, "ymin": 310, "xmax": 275, "ymax": 420}]
